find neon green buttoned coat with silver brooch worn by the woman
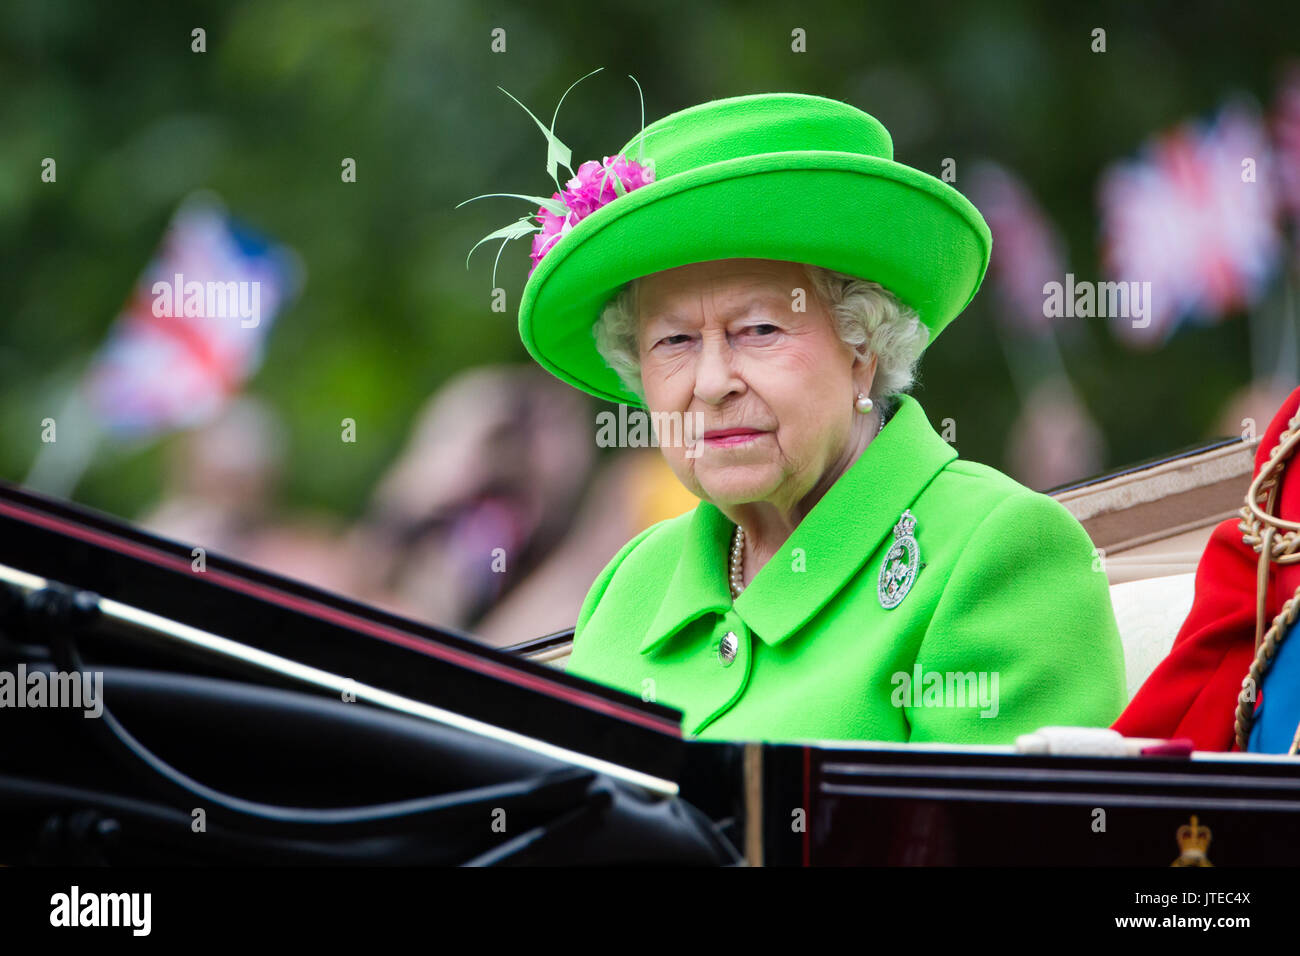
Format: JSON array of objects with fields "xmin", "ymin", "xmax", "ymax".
[{"xmin": 568, "ymin": 395, "xmax": 1126, "ymax": 744}]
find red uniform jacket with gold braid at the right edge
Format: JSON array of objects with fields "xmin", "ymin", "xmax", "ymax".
[{"xmin": 1113, "ymin": 389, "xmax": 1300, "ymax": 750}]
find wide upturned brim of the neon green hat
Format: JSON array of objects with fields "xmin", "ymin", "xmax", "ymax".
[{"xmin": 519, "ymin": 151, "xmax": 992, "ymax": 407}]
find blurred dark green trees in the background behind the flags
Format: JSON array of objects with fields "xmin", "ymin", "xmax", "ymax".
[{"xmin": 0, "ymin": 0, "xmax": 1300, "ymax": 516}]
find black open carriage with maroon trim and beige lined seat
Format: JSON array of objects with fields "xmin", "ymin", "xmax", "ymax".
[{"xmin": 0, "ymin": 440, "xmax": 1300, "ymax": 865}]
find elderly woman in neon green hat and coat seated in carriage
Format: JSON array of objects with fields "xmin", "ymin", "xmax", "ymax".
[{"xmin": 470, "ymin": 85, "xmax": 1125, "ymax": 744}]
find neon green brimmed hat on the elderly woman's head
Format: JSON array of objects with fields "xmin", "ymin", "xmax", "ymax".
[{"xmin": 473, "ymin": 83, "xmax": 993, "ymax": 407}]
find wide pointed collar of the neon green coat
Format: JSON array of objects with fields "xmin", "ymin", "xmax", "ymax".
[{"xmin": 640, "ymin": 394, "xmax": 957, "ymax": 654}]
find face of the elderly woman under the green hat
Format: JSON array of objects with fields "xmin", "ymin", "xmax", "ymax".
[{"xmin": 637, "ymin": 259, "xmax": 875, "ymax": 510}]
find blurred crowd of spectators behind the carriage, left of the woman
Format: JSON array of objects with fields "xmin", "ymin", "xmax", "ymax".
[{"xmin": 140, "ymin": 365, "xmax": 697, "ymax": 646}]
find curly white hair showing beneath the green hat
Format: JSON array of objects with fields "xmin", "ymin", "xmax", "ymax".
[{"xmin": 592, "ymin": 264, "xmax": 930, "ymax": 411}]
